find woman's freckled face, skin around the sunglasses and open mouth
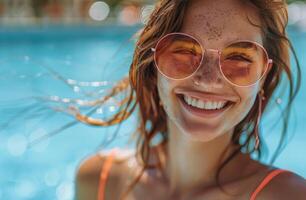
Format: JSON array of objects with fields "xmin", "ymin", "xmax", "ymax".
[{"xmin": 157, "ymin": 0, "xmax": 264, "ymax": 141}]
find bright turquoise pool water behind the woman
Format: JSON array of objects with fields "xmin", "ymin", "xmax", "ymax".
[{"xmin": 0, "ymin": 26, "xmax": 306, "ymax": 200}]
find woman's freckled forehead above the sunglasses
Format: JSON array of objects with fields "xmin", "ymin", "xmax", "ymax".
[{"xmin": 181, "ymin": 0, "xmax": 262, "ymax": 48}]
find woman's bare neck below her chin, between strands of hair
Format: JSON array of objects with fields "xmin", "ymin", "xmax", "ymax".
[{"xmin": 158, "ymin": 120, "xmax": 251, "ymax": 194}]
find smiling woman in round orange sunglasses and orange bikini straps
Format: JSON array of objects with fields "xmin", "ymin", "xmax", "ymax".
[{"xmin": 76, "ymin": 0, "xmax": 306, "ymax": 200}]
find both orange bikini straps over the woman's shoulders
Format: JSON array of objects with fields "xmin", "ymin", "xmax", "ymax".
[{"xmin": 97, "ymin": 149, "xmax": 290, "ymax": 200}]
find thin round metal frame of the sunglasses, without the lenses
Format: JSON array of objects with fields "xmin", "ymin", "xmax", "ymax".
[{"xmin": 151, "ymin": 32, "xmax": 273, "ymax": 87}]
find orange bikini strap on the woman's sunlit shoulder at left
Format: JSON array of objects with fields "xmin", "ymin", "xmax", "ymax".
[{"xmin": 98, "ymin": 149, "xmax": 117, "ymax": 200}]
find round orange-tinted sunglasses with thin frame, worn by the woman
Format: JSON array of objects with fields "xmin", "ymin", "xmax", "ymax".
[{"xmin": 151, "ymin": 32, "xmax": 273, "ymax": 87}]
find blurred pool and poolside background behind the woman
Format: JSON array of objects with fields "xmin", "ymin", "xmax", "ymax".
[{"xmin": 0, "ymin": 0, "xmax": 306, "ymax": 200}]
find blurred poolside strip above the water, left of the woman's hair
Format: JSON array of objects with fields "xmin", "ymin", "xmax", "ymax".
[{"xmin": 0, "ymin": 0, "xmax": 154, "ymax": 25}]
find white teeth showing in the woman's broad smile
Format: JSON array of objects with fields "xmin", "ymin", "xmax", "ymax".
[{"xmin": 184, "ymin": 95, "xmax": 227, "ymax": 110}]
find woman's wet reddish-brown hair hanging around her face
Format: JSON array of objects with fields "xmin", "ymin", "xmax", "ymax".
[{"xmin": 76, "ymin": 0, "xmax": 301, "ymax": 197}]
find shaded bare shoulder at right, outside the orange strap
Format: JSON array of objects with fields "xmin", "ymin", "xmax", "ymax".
[{"xmin": 258, "ymin": 172, "xmax": 306, "ymax": 200}]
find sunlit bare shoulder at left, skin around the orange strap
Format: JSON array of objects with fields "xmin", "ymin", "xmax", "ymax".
[{"xmin": 75, "ymin": 149, "xmax": 134, "ymax": 200}]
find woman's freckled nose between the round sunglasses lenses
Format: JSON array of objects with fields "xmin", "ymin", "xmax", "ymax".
[{"xmin": 192, "ymin": 49, "xmax": 223, "ymax": 87}]
